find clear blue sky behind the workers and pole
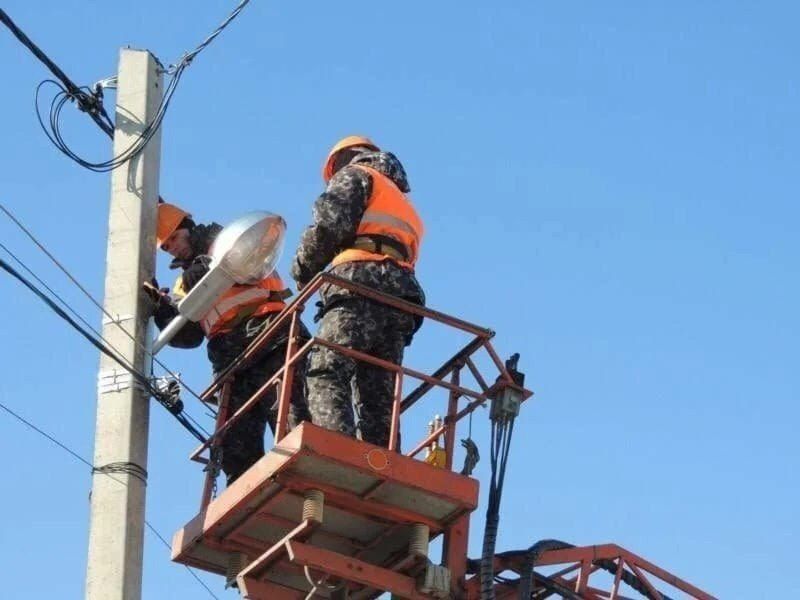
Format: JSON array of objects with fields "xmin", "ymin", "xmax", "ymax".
[{"xmin": 0, "ymin": 0, "xmax": 800, "ymax": 598}]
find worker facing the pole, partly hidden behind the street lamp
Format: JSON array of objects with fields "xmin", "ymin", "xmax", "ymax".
[{"xmin": 145, "ymin": 202, "xmax": 311, "ymax": 485}]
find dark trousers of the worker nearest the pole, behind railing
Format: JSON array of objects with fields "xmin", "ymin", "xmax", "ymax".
[{"xmin": 208, "ymin": 317, "xmax": 311, "ymax": 485}]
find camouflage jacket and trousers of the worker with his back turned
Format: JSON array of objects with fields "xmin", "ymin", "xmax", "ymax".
[{"xmin": 291, "ymin": 152, "xmax": 425, "ymax": 446}]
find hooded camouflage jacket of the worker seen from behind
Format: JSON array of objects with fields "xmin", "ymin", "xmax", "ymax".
[{"xmin": 291, "ymin": 152, "xmax": 425, "ymax": 306}]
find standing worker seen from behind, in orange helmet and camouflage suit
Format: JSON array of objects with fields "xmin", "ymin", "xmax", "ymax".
[{"xmin": 291, "ymin": 136, "xmax": 425, "ymax": 446}]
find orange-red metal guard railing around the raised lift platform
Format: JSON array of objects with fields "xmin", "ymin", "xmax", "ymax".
[{"xmin": 191, "ymin": 273, "xmax": 532, "ymax": 508}]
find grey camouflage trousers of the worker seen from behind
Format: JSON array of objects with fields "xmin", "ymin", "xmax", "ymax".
[{"xmin": 306, "ymin": 296, "xmax": 414, "ymax": 446}]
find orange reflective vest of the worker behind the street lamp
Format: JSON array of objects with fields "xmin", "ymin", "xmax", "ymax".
[{"xmin": 174, "ymin": 271, "xmax": 292, "ymax": 338}]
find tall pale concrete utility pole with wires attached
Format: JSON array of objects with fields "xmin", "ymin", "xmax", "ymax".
[{"xmin": 86, "ymin": 49, "xmax": 163, "ymax": 600}]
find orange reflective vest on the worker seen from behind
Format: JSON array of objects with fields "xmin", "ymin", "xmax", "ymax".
[{"xmin": 331, "ymin": 165, "xmax": 425, "ymax": 269}]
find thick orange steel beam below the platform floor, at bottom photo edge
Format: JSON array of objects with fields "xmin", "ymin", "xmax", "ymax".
[{"xmin": 286, "ymin": 541, "xmax": 430, "ymax": 600}]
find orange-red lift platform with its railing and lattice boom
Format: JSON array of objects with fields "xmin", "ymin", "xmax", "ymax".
[{"xmin": 172, "ymin": 273, "xmax": 714, "ymax": 600}]
